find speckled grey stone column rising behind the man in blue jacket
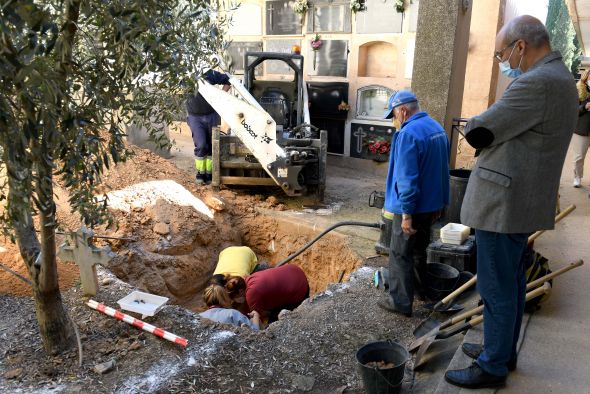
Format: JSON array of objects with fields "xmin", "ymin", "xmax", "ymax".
[{"xmin": 412, "ymin": 0, "xmax": 472, "ymax": 168}]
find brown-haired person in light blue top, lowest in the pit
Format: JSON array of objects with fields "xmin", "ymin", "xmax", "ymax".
[{"xmin": 200, "ymin": 285, "xmax": 260, "ymax": 331}]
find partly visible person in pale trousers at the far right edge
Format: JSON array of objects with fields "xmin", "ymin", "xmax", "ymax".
[{"xmin": 572, "ymin": 70, "xmax": 590, "ymax": 187}]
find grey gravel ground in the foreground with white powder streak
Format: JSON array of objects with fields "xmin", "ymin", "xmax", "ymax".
[{"xmin": 0, "ymin": 258, "xmax": 425, "ymax": 393}]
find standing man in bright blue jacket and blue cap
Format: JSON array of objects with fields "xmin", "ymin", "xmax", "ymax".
[{"xmin": 379, "ymin": 90, "xmax": 449, "ymax": 317}]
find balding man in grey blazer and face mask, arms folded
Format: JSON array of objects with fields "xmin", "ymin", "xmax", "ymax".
[{"xmin": 445, "ymin": 15, "xmax": 578, "ymax": 388}]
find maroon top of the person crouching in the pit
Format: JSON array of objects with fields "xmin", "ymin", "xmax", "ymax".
[{"xmin": 246, "ymin": 264, "xmax": 309, "ymax": 321}]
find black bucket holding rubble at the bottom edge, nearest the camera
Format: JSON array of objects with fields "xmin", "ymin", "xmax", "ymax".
[{"xmin": 356, "ymin": 341, "xmax": 410, "ymax": 394}]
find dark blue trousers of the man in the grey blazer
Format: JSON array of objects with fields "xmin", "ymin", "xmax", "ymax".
[{"xmin": 475, "ymin": 230, "xmax": 528, "ymax": 376}]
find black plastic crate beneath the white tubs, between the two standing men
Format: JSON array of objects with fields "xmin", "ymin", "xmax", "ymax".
[{"xmin": 426, "ymin": 235, "xmax": 477, "ymax": 274}]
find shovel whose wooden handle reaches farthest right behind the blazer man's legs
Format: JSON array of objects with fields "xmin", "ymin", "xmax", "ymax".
[{"xmin": 408, "ymin": 260, "xmax": 584, "ymax": 346}]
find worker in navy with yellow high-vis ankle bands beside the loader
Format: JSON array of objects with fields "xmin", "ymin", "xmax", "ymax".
[{"xmin": 186, "ymin": 70, "xmax": 231, "ymax": 184}]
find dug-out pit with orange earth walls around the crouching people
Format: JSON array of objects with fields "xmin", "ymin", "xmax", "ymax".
[{"xmin": 108, "ymin": 191, "xmax": 362, "ymax": 311}]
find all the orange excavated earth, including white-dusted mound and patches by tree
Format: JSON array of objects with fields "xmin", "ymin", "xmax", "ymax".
[{"xmin": 0, "ymin": 148, "xmax": 362, "ymax": 311}]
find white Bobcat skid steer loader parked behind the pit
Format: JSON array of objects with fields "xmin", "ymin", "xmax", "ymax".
[{"xmin": 199, "ymin": 52, "xmax": 328, "ymax": 201}]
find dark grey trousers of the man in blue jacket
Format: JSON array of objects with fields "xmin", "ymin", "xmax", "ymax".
[{"xmin": 389, "ymin": 212, "xmax": 433, "ymax": 313}]
